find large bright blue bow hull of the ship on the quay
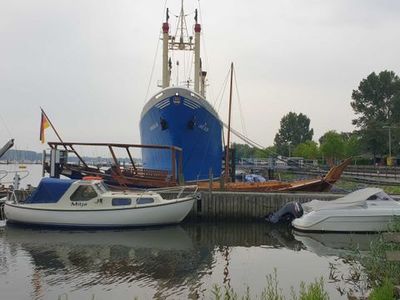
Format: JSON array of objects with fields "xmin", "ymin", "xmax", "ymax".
[{"xmin": 140, "ymin": 87, "xmax": 223, "ymax": 181}]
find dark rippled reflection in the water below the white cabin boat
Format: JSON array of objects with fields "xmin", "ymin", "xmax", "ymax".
[{"xmin": 2, "ymin": 226, "xmax": 212, "ymax": 294}]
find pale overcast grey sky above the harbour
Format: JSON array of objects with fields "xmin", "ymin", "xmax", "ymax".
[{"xmin": 0, "ymin": 0, "xmax": 400, "ymax": 155}]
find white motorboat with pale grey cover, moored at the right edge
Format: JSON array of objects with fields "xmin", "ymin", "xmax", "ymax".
[{"xmin": 292, "ymin": 188, "xmax": 400, "ymax": 232}]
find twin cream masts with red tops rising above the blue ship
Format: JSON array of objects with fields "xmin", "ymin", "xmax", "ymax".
[{"xmin": 162, "ymin": 0, "xmax": 207, "ymax": 97}]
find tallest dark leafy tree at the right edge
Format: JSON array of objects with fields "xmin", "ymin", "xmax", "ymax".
[{"xmin": 351, "ymin": 70, "xmax": 400, "ymax": 157}]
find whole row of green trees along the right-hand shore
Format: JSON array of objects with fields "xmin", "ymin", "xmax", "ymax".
[{"xmin": 235, "ymin": 70, "xmax": 400, "ymax": 163}]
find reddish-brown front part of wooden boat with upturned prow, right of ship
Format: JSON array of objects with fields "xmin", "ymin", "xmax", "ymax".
[{"xmin": 199, "ymin": 158, "xmax": 351, "ymax": 192}]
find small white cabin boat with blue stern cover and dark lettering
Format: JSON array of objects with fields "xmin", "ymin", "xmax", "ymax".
[{"xmin": 4, "ymin": 178, "xmax": 197, "ymax": 227}]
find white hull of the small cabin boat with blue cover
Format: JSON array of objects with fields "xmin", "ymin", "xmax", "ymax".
[{"xmin": 4, "ymin": 198, "xmax": 195, "ymax": 228}]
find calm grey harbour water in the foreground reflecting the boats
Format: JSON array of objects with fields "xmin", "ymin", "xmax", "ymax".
[{"xmin": 0, "ymin": 166, "xmax": 374, "ymax": 300}]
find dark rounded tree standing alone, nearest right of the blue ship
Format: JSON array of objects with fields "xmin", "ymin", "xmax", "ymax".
[{"xmin": 274, "ymin": 112, "xmax": 314, "ymax": 156}]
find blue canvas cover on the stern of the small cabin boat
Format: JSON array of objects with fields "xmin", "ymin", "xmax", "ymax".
[{"xmin": 25, "ymin": 178, "xmax": 75, "ymax": 203}]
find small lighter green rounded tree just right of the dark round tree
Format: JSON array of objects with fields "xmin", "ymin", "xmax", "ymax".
[{"xmin": 319, "ymin": 130, "xmax": 345, "ymax": 165}]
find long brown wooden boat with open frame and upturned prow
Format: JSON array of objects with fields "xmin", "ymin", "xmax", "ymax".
[{"xmin": 44, "ymin": 142, "xmax": 351, "ymax": 192}]
